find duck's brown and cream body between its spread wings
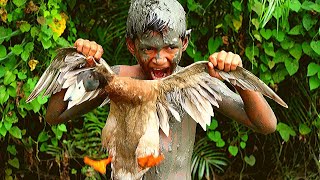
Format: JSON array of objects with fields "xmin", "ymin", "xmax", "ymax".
[{"xmin": 101, "ymin": 76, "xmax": 162, "ymax": 179}]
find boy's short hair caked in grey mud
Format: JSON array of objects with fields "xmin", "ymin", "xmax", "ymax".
[{"xmin": 126, "ymin": 0, "xmax": 186, "ymax": 39}]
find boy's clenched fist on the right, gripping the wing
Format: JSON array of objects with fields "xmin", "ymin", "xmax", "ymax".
[{"xmin": 208, "ymin": 51, "xmax": 242, "ymax": 79}]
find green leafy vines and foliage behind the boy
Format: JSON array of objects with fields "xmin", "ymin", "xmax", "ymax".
[{"xmin": 0, "ymin": 0, "xmax": 320, "ymax": 180}]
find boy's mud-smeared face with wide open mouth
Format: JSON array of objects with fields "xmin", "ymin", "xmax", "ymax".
[{"xmin": 127, "ymin": 31, "xmax": 188, "ymax": 79}]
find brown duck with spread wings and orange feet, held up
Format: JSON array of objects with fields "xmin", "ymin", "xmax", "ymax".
[{"xmin": 26, "ymin": 47, "xmax": 288, "ymax": 179}]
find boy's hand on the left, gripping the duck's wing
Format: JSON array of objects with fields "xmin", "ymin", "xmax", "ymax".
[{"xmin": 74, "ymin": 39, "xmax": 103, "ymax": 66}]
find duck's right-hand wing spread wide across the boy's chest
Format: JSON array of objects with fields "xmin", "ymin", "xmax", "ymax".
[{"xmin": 157, "ymin": 61, "xmax": 288, "ymax": 135}]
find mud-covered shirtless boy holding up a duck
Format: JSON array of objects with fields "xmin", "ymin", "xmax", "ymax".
[{"xmin": 46, "ymin": 0, "xmax": 277, "ymax": 179}]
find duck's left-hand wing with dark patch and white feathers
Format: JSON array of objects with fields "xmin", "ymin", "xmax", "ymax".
[{"xmin": 27, "ymin": 47, "xmax": 109, "ymax": 109}]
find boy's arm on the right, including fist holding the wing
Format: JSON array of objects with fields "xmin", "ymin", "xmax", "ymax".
[{"xmin": 208, "ymin": 51, "xmax": 277, "ymax": 134}]
